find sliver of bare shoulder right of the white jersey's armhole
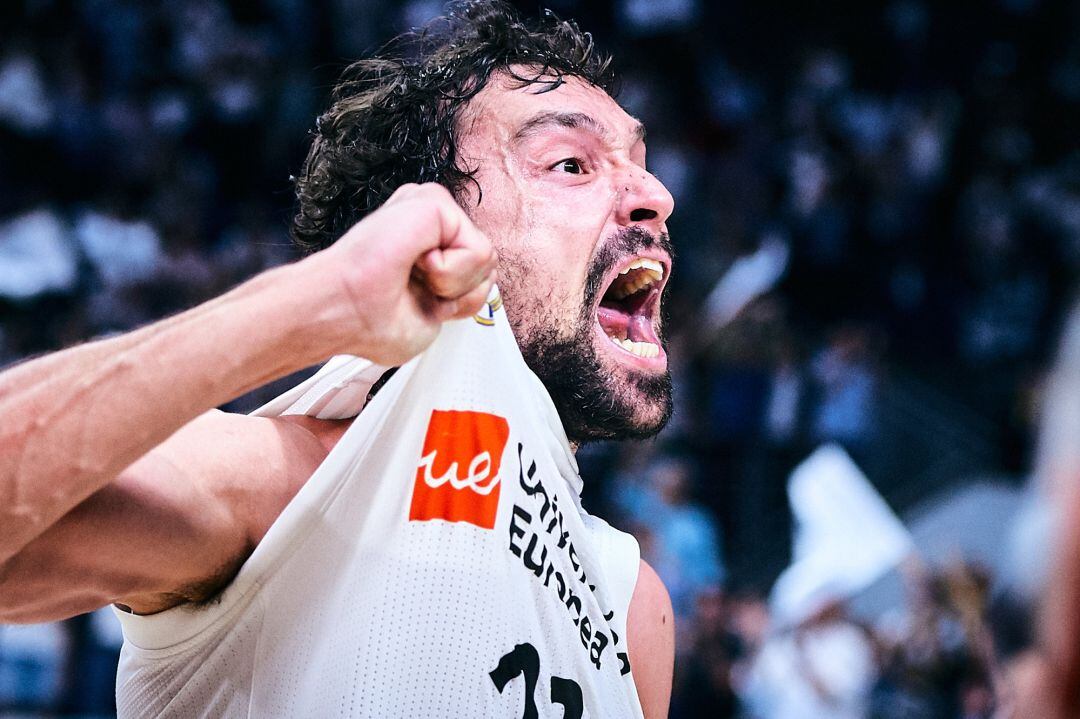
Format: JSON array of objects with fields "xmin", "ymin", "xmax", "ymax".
[{"xmin": 626, "ymin": 559, "xmax": 675, "ymax": 719}]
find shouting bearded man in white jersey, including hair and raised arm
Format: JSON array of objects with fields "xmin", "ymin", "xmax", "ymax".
[{"xmin": 0, "ymin": 1, "xmax": 674, "ymax": 717}]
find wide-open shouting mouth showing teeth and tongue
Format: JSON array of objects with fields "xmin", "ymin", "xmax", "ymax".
[{"xmin": 596, "ymin": 257, "xmax": 667, "ymax": 364}]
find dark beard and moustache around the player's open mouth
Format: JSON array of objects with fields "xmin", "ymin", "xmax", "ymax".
[{"xmin": 512, "ymin": 227, "xmax": 673, "ymax": 445}]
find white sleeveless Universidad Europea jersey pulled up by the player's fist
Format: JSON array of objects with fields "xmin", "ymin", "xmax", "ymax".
[{"xmin": 117, "ymin": 289, "xmax": 642, "ymax": 719}]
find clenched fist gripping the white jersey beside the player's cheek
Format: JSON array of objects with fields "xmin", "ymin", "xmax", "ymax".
[{"xmin": 301, "ymin": 184, "xmax": 497, "ymax": 365}]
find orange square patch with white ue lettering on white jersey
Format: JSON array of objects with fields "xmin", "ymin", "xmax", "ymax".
[{"xmin": 408, "ymin": 409, "xmax": 510, "ymax": 529}]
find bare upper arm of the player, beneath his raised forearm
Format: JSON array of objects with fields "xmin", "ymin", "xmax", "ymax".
[{"xmin": 0, "ymin": 412, "xmax": 321, "ymax": 622}]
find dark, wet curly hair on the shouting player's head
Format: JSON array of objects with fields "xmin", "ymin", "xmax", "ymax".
[{"xmin": 292, "ymin": 0, "xmax": 615, "ymax": 253}]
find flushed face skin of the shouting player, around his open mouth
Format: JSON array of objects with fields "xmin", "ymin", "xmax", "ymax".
[{"xmin": 459, "ymin": 78, "xmax": 674, "ymax": 442}]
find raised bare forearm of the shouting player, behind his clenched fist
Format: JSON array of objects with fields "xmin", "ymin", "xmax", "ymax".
[{"xmin": 0, "ymin": 258, "xmax": 346, "ymax": 561}]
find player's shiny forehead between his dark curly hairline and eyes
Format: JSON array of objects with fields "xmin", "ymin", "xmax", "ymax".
[{"xmin": 460, "ymin": 77, "xmax": 645, "ymax": 146}]
